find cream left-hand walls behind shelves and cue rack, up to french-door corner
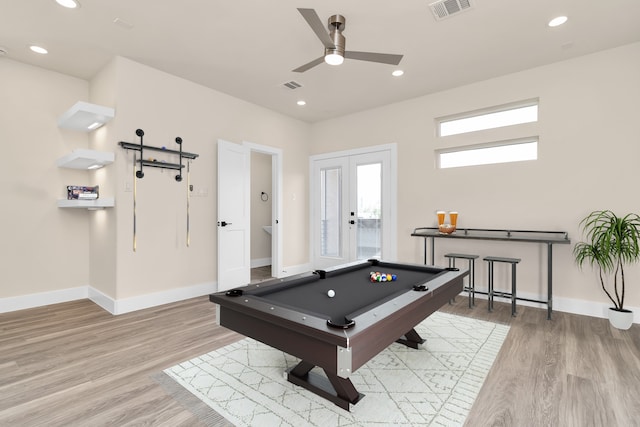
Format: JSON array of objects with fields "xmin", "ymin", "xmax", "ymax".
[{"xmin": 0, "ymin": 58, "xmax": 309, "ymax": 312}]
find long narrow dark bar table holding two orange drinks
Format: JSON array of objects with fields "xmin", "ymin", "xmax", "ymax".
[{"xmin": 411, "ymin": 227, "xmax": 571, "ymax": 319}]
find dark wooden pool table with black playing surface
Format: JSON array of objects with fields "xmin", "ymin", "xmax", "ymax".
[{"xmin": 209, "ymin": 260, "xmax": 468, "ymax": 410}]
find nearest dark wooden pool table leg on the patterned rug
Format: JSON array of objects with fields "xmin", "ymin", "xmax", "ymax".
[{"xmin": 287, "ymin": 360, "xmax": 364, "ymax": 411}]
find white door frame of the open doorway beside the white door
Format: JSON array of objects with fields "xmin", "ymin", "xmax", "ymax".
[{"xmin": 242, "ymin": 141, "xmax": 284, "ymax": 278}]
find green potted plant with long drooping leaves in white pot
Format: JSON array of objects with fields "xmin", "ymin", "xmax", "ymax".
[{"xmin": 573, "ymin": 210, "xmax": 640, "ymax": 329}]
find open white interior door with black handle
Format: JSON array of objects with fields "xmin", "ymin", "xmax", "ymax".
[{"xmin": 218, "ymin": 140, "xmax": 251, "ymax": 291}]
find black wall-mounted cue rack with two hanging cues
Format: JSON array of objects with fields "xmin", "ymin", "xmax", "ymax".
[{"xmin": 119, "ymin": 129, "xmax": 198, "ymax": 252}]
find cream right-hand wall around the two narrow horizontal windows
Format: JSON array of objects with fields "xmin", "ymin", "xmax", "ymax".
[{"xmin": 311, "ymin": 43, "xmax": 640, "ymax": 321}]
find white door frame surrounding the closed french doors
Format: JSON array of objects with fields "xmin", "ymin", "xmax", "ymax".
[{"xmin": 309, "ymin": 143, "xmax": 398, "ymax": 263}]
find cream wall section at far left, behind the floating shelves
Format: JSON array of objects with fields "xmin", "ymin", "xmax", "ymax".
[{"xmin": 0, "ymin": 58, "xmax": 91, "ymax": 300}]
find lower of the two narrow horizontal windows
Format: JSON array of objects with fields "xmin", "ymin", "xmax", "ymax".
[{"xmin": 437, "ymin": 138, "xmax": 538, "ymax": 169}]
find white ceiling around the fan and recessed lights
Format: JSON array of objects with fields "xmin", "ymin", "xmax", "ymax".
[{"xmin": 0, "ymin": 0, "xmax": 640, "ymax": 122}]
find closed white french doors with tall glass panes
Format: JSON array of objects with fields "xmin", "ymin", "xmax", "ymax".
[{"xmin": 311, "ymin": 150, "xmax": 395, "ymax": 268}]
